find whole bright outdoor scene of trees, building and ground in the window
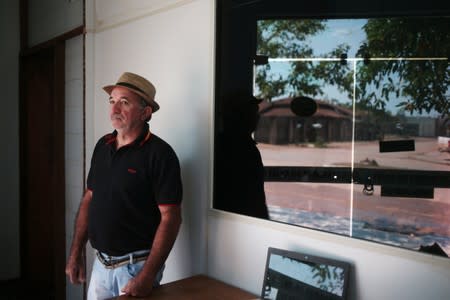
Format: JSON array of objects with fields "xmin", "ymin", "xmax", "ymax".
[{"xmin": 254, "ymin": 17, "xmax": 450, "ymax": 256}]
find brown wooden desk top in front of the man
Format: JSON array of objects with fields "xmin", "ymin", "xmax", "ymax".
[{"xmin": 115, "ymin": 275, "xmax": 259, "ymax": 300}]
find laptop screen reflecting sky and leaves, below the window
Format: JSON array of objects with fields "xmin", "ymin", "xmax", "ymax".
[{"xmin": 261, "ymin": 247, "xmax": 350, "ymax": 300}]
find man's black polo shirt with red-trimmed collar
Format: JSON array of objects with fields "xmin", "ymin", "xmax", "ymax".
[{"xmin": 87, "ymin": 124, "xmax": 182, "ymax": 255}]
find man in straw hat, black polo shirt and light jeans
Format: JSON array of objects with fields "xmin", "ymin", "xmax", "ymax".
[{"xmin": 66, "ymin": 72, "xmax": 182, "ymax": 300}]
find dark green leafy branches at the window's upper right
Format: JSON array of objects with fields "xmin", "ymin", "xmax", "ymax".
[{"xmin": 356, "ymin": 18, "xmax": 450, "ymax": 116}]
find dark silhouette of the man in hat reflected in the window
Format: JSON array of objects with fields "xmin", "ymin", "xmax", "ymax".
[{"xmin": 214, "ymin": 92, "xmax": 268, "ymax": 219}]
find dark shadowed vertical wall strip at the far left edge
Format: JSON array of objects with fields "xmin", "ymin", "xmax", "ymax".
[{"xmin": 0, "ymin": 0, "xmax": 20, "ymax": 280}]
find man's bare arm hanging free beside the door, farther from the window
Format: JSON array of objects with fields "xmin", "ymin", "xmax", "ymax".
[{"xmin": 66, "ymin": 190, "xmax": 92, "ymax": 284}]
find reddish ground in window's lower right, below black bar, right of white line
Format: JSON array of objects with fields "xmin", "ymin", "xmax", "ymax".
[{"xmin": 352, "ymin": 185, "xmax": 450, "ymax": 255}]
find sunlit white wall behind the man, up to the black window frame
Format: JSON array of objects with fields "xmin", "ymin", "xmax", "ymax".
[{"xmin": 87, "ymin": 0, "xmax": 214, "ymax": 282}]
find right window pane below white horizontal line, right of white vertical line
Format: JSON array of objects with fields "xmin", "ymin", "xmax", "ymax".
[{"xmin": 353, "ymin": 58, "xmax": 450, "ymax": 255}]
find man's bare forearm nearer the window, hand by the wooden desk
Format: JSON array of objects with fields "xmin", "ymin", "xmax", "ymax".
[{"xmin": 122, "ymin": 205, "xmax": 181, "ymax": 297}]
